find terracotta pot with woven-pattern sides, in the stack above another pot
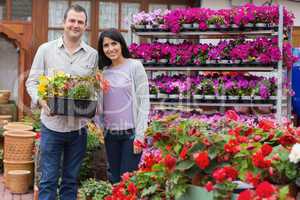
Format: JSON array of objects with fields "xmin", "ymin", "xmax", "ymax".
[{"xmin": 4, "ymin": 130, "xmax": 35, "ymax": 161}]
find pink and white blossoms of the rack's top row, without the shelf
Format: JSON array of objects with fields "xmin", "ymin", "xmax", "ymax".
[{"xmin": 132, "ymin": 3, "xmax": 295, "ymax": 33}]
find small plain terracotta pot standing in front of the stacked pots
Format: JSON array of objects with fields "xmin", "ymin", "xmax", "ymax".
[{"xmin": 7, "ymin": 170, "xmax": 30, "ymax": 194}]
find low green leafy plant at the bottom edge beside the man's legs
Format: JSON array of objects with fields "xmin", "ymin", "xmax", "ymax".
[{"xmin": 79, "ymin": 179, "xmax": 112, "ymax": 200}]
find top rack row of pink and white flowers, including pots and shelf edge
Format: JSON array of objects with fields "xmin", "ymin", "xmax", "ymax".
[{"xmin": 131, "ymin": 3, "xmax": 294, "ymax": 36}]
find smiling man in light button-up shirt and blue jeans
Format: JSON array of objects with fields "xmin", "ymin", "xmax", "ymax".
[{"xmin": 26, "ymin": 5, "xmax": 97, "ymax": 200}]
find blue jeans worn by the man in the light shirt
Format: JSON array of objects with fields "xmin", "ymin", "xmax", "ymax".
[{"xmin": 39, "ymin": 125, "xmax": 87, "ymax": 200}]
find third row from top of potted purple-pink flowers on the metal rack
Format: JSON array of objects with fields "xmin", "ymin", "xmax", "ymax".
[{"xmin": 149, "ymin": 73, "xmax": 292, "ymax": 106}]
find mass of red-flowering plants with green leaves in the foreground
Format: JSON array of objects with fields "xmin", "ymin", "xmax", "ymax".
[{"xmin": 106, "ymin": 111, "xmax": 300, "ymax": 200}]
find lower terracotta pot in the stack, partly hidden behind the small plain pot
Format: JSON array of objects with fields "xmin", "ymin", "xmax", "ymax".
[{"xmin": 3, "ymin": 160, "xmax": 34, "ymax": 187}]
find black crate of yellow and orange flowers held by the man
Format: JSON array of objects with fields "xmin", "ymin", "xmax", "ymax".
[{"xmin": 38, "ymin": 71, "xmax": 109, "ymax": 117}]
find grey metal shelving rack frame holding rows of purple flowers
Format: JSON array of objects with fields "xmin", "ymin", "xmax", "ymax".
[{"xmin": 130, "ymin": 5, "xmax": 291, "ymax": 123}]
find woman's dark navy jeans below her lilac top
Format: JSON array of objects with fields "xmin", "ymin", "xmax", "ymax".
[{"xmin": 104, "ymin": 130, "xmax": 141, "ymax": 183}]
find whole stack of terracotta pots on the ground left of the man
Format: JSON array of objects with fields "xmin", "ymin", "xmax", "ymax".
[{"xmin": 3, "ymin": 122, "xmax": 35, "ymax": 193}]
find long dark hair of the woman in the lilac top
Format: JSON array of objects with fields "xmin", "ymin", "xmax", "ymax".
[{"xmin": 98, "ymin": 28, "xmax": 131, "ymax": 69}]
